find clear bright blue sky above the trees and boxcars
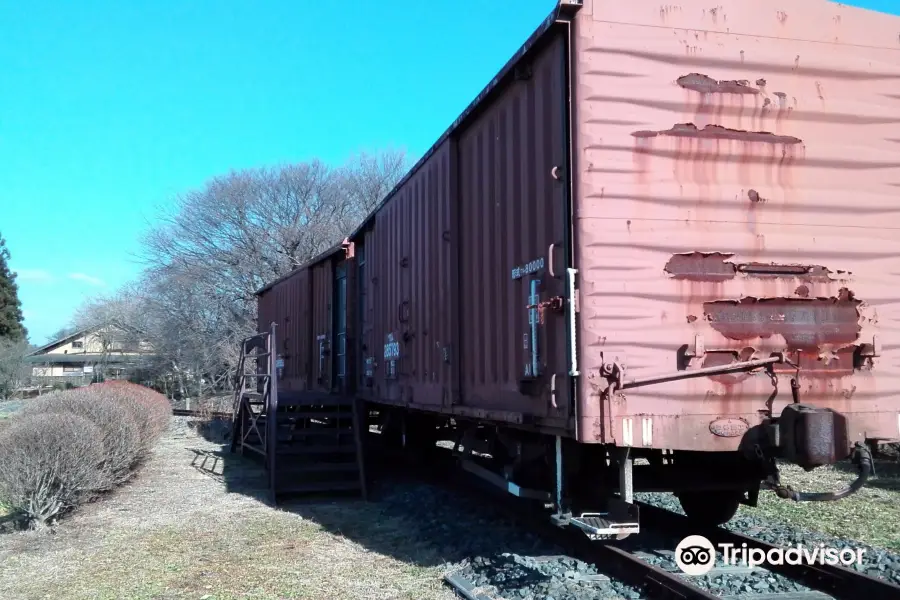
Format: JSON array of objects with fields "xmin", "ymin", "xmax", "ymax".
[{"xmin": 0, "ymin": 0, "xmax": 898, "ymax": 343}]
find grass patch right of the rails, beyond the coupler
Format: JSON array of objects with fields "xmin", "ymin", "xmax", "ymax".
[{"xmin": 738, "ymin": 461, "xmax": 900, "ymax": 550}]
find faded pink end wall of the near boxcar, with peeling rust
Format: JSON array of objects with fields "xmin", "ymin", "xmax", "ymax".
[{"xmin": 573, "ymin": 0, "xmax": 900, "ymax": 450}]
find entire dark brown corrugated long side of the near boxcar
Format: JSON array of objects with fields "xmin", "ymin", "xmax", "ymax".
[{"xmin": 261, "ymin": 30, "xmax": 569, "ymax": 432}]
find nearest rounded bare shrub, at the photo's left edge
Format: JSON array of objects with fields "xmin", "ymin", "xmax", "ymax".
[{"xmin": 0, "ymin": 413, "xmax": 106, "ymax": 527}]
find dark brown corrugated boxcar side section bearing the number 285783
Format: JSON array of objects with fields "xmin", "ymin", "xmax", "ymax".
[{"xmin": 365, "ymin": 142, "xmax": 452, "ymax": 405}]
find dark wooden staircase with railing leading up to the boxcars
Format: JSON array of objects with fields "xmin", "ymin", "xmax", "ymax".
[{"xmin": 231, "ymin": 323, "xmax": 367, "ymax": 503}]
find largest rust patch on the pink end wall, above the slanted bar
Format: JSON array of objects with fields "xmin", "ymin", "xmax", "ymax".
[{"xmin": 703, "ymin": 288, "xmax": 862, "ymax": 350}]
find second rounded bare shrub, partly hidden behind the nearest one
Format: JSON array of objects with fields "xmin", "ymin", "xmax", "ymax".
[{"xmin": 23, "ymin": 388, "xmax": 146, "ymax": 490}]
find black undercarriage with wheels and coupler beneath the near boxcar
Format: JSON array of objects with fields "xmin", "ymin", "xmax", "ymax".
[{"xmin": 370, "ymin": 404, "xmax": 872, "ymax": 539}]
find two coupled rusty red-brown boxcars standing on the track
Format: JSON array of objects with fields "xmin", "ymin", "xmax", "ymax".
[{"xmin": 259, "ymin": 0, "xmax": 900, "ymax": 534}]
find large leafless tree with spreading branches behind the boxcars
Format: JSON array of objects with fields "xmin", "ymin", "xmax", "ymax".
[{"xmin": 77, "ymin": 150, "xmax": 407, "ymax": 396}]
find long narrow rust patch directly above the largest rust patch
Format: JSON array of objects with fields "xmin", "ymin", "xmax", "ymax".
[{"xmin": 664, "ymin": 252, "xmax": 843, "ymax": 284}]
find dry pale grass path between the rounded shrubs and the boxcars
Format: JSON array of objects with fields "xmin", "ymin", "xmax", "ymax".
[{"xmin": 0, "ymin": 422, "xmax": 454, "ymax": 600}]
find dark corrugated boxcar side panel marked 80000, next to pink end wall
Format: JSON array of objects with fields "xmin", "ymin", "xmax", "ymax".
[{"xmin": 458, "ymin": 31, "xmax": 568, "ymax": 416}]
